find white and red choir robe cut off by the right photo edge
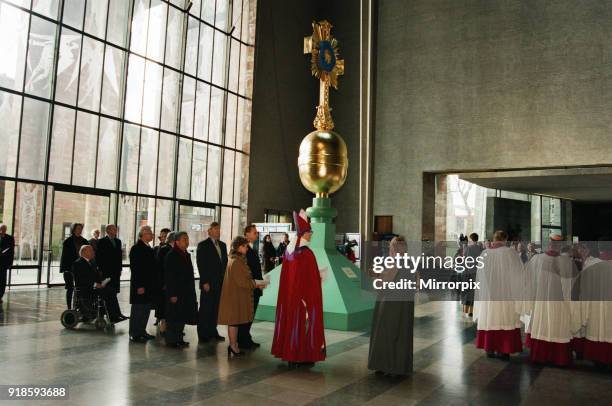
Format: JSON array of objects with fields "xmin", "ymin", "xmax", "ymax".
[{"xmin": 579, "ymin": 260, "xmax": 612, "ymax": 364}]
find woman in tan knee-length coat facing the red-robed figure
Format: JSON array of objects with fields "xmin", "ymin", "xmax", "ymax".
[{"xmin": 218, "ymin": 237, "xmax": 264, "ymax": 356}]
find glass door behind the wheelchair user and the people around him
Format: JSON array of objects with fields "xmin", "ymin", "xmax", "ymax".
[{"xmin": 43, "ymin": 189, "xmax": 110, "ymax": 286}]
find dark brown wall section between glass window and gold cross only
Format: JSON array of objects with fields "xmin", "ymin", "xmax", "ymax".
[{"xmin": 247, "ymin": 0, "xmax": 318, "ymax": 222}]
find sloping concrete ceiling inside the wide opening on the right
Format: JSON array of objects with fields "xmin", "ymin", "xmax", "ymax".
[{"xmin": 459, "ymin": 167, "xmax": 612, "ymax": 202}]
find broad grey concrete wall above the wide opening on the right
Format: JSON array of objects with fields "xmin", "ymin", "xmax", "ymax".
[{"xmin": 374, "ymin": 0, "xmax": 612, "ymax": 238}]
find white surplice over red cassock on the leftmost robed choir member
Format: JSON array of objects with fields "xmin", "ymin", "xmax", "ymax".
[{"xmin": 474, "ymin": 246, "xmax": 525, "ymax": 354}]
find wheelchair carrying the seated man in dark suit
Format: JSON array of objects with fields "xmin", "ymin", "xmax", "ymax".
[{"xmin": 60, "ymin": 274, "xmax": 115, "ymax": 332}]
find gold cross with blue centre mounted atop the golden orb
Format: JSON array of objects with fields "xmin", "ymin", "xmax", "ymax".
[{"xmin": 304, "ymin": 20, "xmax": 344, "ymax": 131}]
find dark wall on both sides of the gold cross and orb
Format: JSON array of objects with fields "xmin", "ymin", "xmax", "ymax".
[{"xmin": 248, "ymin": 0, "xmax": 360, "ymax": 232}]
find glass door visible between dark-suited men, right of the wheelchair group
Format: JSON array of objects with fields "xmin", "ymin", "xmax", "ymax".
[{"xmin": 178, "ymin": 203, "xmax": 218, "ymax": 277}]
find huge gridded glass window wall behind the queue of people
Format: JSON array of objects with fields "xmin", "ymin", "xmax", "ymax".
[{"xmin": 0, "ymin": 0, "xmax": 256, "ymax": 283}]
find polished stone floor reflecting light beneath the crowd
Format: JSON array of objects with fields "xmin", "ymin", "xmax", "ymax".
[{"xmin": 0, "ymin": 288, "xmax": 612, "ymax": 406}]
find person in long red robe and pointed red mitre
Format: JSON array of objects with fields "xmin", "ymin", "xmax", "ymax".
[{"xmin": 271, "ymin": 210, "xmax": 325, "ymax": 368}]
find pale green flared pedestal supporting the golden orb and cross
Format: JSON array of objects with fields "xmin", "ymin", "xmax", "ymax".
[{"xmin": 255, "ymin": 198, "xmax": 375, "ymax": 331}]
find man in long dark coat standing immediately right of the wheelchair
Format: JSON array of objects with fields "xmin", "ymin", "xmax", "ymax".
[{"xmin": 130, "ymin": 226, "xmax": 157, "ymax": 343}]
